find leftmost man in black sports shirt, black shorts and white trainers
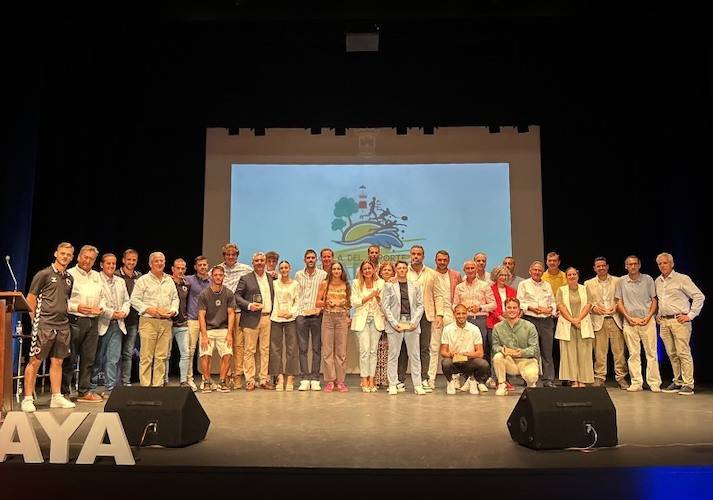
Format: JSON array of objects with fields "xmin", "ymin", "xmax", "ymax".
[{"xmin": 22, "ymin": 243, "xmax": 75, "ymax": 413}]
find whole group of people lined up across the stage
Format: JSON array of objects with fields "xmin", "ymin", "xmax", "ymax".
[{"xmin": 22, "ymin": 243, "xmax": 705, "ymax": 412}]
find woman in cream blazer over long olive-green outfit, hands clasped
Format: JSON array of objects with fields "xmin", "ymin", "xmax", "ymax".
[{"xmin": 555, "ymin": 267, "xmax": 594, "ymax": 387}]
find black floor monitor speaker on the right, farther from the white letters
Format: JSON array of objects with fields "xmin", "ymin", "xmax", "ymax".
[{"xmin": 508, "ymin": 387, "xmax": 618, "ymax": 450}]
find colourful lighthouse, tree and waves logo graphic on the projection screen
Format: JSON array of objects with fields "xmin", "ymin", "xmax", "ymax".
[{"xmin": 332, "ymin": 185, "xmax": 408, "ymax": 249}]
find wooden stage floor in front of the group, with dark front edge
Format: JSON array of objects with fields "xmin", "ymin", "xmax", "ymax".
[{"xmin": 0, "ymin": 376, "xmax": 713, "ymax": 498}]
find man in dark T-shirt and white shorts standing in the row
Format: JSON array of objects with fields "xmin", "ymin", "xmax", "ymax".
[{"xmin": 198, "ymin": 266, "xmax": 235, "ymax": 392}]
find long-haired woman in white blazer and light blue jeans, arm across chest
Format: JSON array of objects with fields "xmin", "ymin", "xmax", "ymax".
[{"xmin": 351, "ymin": 260, "xmax": 384, "ymax": 392}]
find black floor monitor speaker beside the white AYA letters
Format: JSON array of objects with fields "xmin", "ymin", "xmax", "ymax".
[{"xmin": 104, "ymin": 386, "xmax": 210, "ymax": 447}]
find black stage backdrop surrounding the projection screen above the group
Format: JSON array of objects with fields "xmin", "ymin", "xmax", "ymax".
[{"xmin": 0, "ymin": 1, "xmax": 713, "ymax": 381}]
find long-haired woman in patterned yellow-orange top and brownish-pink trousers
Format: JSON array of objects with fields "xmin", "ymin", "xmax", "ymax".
[{"xmin": 316, "ymin": 262, "xmax": 351, "ymax": 392}]
